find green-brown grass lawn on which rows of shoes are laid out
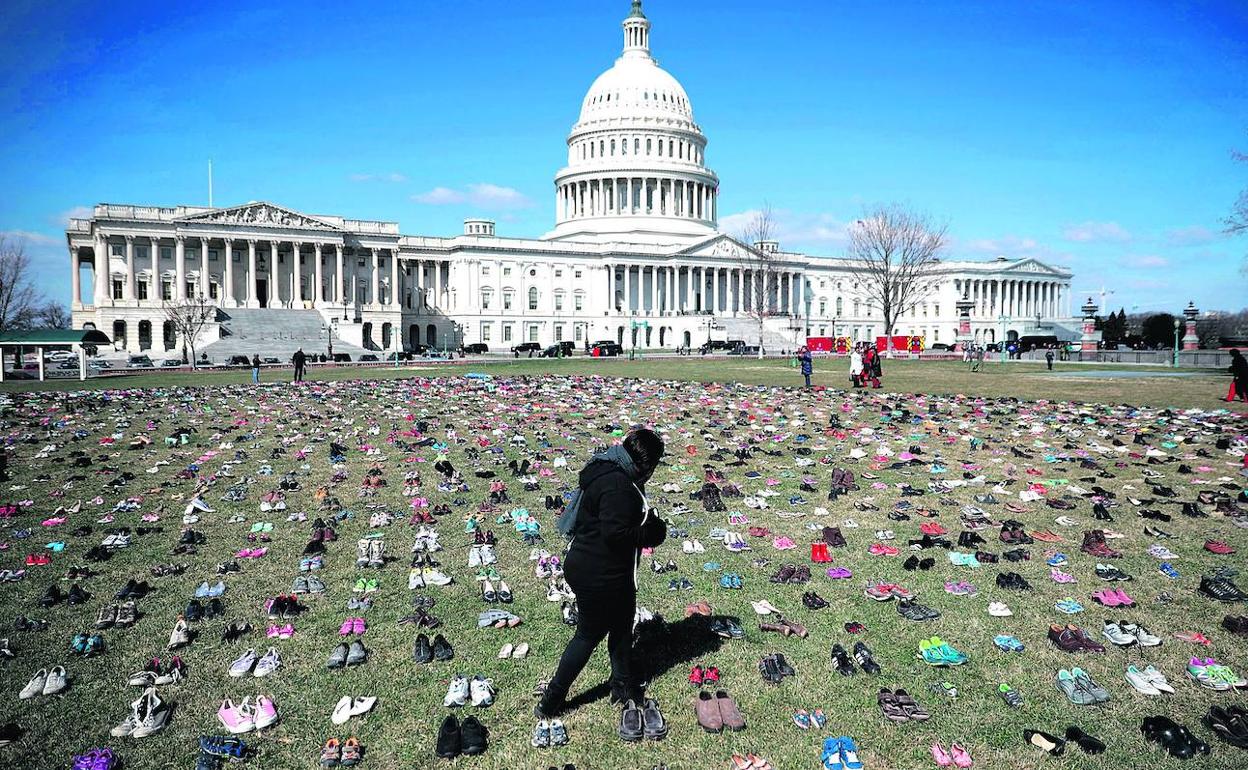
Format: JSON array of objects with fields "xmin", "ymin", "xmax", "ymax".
[{"xmin": 0, "ymin": 358, "xmax": 1248, "ymax": 770}]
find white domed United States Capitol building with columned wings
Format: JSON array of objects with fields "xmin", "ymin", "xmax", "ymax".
[{"xmin": 66, "ymin": 0, "xmax": 1077, "ymax": 359}]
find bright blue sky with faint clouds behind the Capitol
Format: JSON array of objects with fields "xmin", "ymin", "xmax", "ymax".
[{"xmin": 0, "ymin": 0, "xmax": 1248, "ymax": 311}]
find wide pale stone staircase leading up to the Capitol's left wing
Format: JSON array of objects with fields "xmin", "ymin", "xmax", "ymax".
[{"xmin": 202, "ymin": 308, "xmax": 367, "ymax": 362}]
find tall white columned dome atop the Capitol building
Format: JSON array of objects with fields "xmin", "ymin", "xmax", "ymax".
[{"xmin": 545, "ymin": 0, "xmax": 719, "ymax": 243}]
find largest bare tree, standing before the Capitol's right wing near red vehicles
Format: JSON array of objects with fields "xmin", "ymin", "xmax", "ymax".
[{"xmin": 849, "ymin": 203, "xmax": 947, "ymax": 352}]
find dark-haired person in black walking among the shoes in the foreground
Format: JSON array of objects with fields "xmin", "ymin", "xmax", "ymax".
[{"xmin": 534, "ymin": 428, "xmax": 668, "ymax": 719}]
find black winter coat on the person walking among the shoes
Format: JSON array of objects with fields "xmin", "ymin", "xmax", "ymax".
[{"xmin": 563, "ymin": 461, "xmax": 668, "ymax": 599}]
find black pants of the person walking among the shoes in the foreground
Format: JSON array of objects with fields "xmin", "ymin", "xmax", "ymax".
[{"xmin": 543, "ymin": 592, "xmax": 636, "ymax": 708}]
